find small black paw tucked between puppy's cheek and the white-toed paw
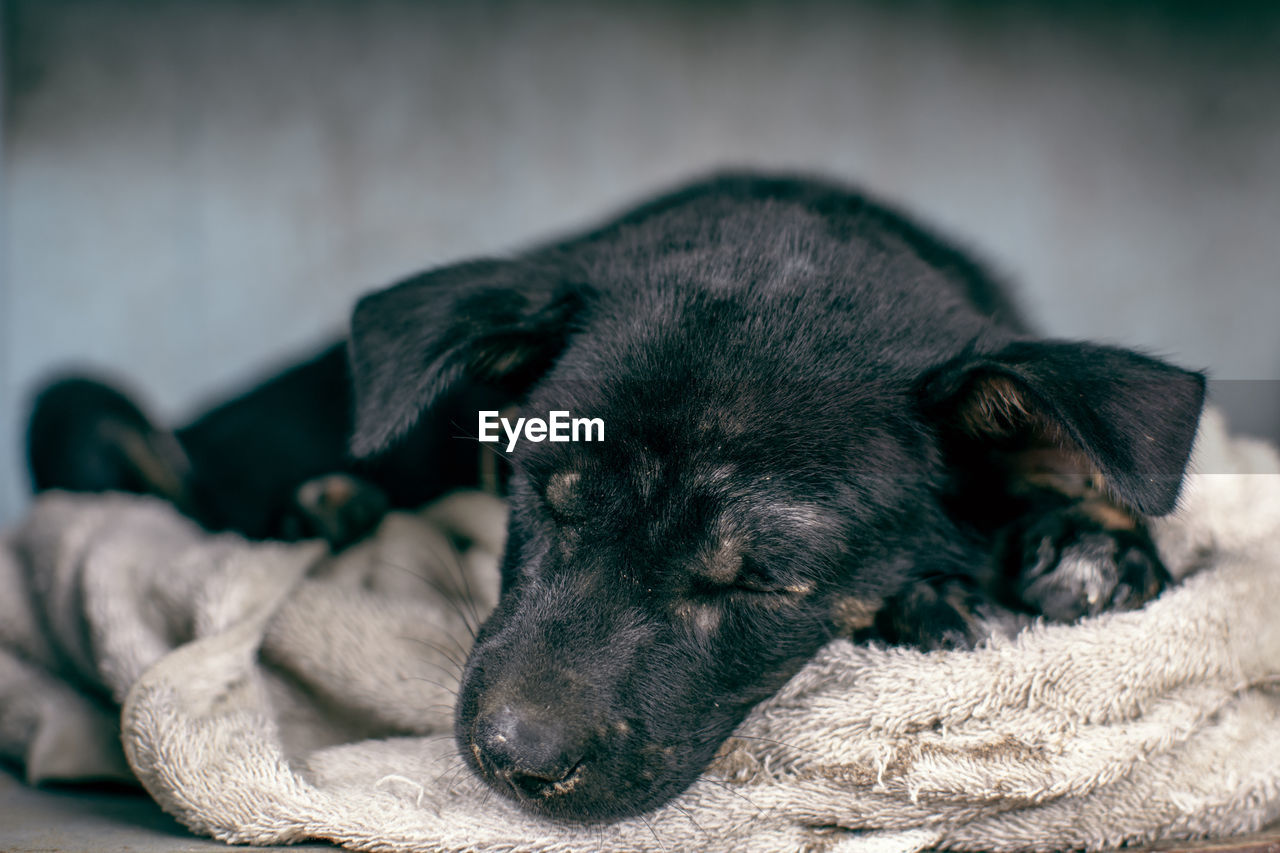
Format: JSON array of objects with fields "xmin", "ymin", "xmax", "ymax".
[{"xmin": 876, "ymin": 578, "xmax": 989, "ymax": 651}]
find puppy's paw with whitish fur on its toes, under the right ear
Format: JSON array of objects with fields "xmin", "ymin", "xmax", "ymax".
[{"xmin": 1015, "ymin": 506, "xmax": 1172, "ymax": 622}]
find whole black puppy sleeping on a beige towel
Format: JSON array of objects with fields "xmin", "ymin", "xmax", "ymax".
[{"xmin": 31, "ymin": 174, "xmax": 1204, "ymax": 821}]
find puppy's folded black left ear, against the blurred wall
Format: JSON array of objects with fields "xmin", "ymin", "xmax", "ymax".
[{"xmin": 349, "ymin": 260, "xmax": 582, "ymax": 457}]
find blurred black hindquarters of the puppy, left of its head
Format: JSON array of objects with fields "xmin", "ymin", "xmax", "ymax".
[{"xmin": 27, "ymin": 342, "xmax": 506, "ymax": 547}]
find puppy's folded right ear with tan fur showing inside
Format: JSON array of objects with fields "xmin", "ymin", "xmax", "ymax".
[{"xmin": 923, "ymin": 341, "xmax": 1204, "ymax": 515}]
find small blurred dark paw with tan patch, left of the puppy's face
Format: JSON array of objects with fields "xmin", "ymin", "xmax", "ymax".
[{"xmin": 284, "ymin": 474, "xmax": 389, "ymax": 551}]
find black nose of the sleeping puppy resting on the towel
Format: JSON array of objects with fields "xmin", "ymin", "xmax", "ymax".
[{"xmin": 472, "ymin": 704, "xmax": 584, "ymax": 798}]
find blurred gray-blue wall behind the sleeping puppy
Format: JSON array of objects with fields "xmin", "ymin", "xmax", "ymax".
[{"xmin": 0, "ymin": 0, "xmax": 1280, "ymax": 521}]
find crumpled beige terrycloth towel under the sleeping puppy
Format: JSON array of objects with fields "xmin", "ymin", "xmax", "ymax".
[{"xmin": 0, "ymin": 415, "xmax": 1280, "ymax": 852}]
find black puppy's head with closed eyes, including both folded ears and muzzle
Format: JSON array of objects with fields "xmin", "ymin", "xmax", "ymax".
[{"xmin": 352, "ymin": 216, "xmax": 1202, "ymax": 820}]
